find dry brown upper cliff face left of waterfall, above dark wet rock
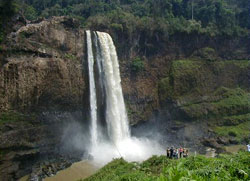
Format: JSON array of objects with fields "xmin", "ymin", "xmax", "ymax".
[{"xmin": 0, "ymin": 17, "xmax": 85, "ymax": 110}]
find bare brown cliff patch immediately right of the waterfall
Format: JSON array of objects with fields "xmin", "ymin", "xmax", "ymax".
[{"xmin": 120, "ymin": 57, "xmax": 169, "ymax": 125}]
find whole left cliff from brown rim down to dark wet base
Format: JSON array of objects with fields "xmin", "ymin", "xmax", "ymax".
[{"xmin": 0, "ymin": 17, "xmax": 88, "ymax": 180}]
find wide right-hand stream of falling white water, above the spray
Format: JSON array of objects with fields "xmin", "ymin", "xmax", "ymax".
[{"xmin": 97, "ymin": 32, "xmax": 130, "ymax": 144}]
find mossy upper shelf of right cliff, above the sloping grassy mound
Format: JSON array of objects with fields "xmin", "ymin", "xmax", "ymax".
[{"xmin": 159, "ymin": 59, "xmax": 250, "ymax": 99}]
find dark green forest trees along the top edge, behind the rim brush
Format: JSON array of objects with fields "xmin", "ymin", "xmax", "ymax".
[{"xmin": 23, "ymin": 0, "xmax": 250, "ymax": 35}]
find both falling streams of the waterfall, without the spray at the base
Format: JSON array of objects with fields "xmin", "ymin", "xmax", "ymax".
[{"xmin": 86, "ymin": 30, "xmax": 130, "ymax": 144}]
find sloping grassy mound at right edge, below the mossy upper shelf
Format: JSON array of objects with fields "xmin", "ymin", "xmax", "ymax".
[{"xmin": 181, "ymin": 87, "xmax": 250, "ymax": 120}]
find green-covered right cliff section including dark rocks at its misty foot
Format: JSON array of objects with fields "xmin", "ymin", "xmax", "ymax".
[{"xmin": 158, "ymin": 59, "xmax": 250, "ymax": 149}]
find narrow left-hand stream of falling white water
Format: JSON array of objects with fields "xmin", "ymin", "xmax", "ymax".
[{"xmin": 86, "ymin": 30, "xmax": 98, "ymax": 146}]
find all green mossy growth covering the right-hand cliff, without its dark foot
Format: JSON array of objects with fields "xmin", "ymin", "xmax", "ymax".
[{"xmin": 159, "ymin": 59, "xmax": 250, "ymax": 143}]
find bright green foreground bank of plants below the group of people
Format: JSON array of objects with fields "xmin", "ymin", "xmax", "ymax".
[{"xmin": 82, "ymin": 152, "xmax": 250, "ymax": 181}]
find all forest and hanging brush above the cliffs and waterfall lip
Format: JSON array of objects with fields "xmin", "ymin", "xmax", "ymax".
[{"xmin": 0, "ymin": 0, "xmax": 250, "ymax": 58}]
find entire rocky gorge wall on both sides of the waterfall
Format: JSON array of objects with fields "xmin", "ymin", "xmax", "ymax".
[{"xmin": 0, "ymin": 17, "xmax": 250, "ymax": 179}]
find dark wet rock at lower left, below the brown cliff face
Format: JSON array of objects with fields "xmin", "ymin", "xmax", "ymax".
[{"xmin": 0, "ymin": 112, "xmax": 85, "ymax": 181}]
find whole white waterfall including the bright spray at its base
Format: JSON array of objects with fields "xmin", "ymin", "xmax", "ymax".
[{"xmin": 86, "ymin": 30, "xmax": 164, "ymax": 164}]
